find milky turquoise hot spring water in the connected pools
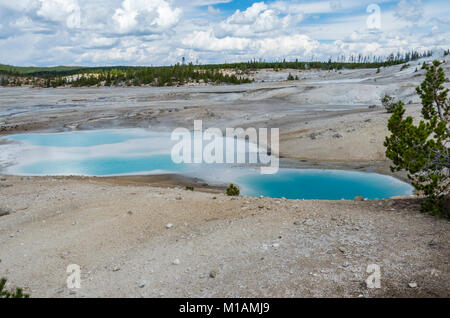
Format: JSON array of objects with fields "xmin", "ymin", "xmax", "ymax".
[{"xmin": 0, "ymin": 129, "xmax": 413, "ymax": 200}]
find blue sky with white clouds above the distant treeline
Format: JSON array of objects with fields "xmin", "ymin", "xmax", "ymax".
[{"xmin": 0, "ymin": 0, "xmax": 450, "ymax": 66}]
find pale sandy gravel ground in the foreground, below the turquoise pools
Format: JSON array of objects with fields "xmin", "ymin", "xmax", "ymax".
[{"xmin": 0, "ymin": 177, "xmax": 450, "ymax": 297}]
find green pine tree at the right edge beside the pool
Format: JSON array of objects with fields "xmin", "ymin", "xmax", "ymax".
[{"xmin": 384, "ymin": 61, "xmax": 450, "ymax": 218}]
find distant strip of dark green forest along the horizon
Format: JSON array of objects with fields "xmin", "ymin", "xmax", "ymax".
[{"xmin": 0, "ymin": 50, "xmax": 442, "ymax": 88}]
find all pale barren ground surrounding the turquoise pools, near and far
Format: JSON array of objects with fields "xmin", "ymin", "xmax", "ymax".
[{"xmin": 0, "ymin": 57, "xmax": 450, "ymax": 297}]
